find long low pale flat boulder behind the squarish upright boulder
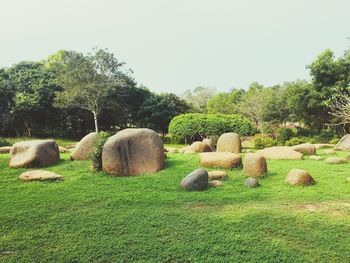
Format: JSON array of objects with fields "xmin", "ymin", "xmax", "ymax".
[{"xmin": 256, "ymin": 146, "xmax": 303, "ymax": 160}]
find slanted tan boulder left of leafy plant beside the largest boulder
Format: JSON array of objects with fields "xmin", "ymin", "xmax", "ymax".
[{"xmin": 70, "ymin": 132, "xmax": 97, "ymax": 161}]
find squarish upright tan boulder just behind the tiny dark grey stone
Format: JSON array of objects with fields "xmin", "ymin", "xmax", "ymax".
[{"xmin": 243, "ymin": 153, "xmax": 267, "ymax": 177}]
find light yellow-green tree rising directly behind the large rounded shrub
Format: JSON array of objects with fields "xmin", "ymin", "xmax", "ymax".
[{"xmin": 207, "ymin": 89, "xmax": 245, "ymax": 114}]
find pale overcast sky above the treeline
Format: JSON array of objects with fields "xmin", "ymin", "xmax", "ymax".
[{"xmin": 0, "ymin": 0, "xmax": 350, "ymax": 94}]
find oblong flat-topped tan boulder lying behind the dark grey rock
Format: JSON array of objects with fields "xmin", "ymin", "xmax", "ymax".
[{"xmin": 199, "ymin": 152, "xmax": 242, "ymax": 169}]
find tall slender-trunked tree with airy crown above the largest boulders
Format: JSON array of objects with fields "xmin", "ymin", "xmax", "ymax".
[{"xmin": 47, "ymin": 49, "xmax": 130, "ymax": 132}]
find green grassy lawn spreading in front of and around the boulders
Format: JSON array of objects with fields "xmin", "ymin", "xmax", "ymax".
[{"xmin": 0, "ymin": 147, "xmax": 350, "ymax": 262}]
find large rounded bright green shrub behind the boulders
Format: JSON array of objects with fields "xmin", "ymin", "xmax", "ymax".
[{"xmin": 169, "ymin": 113, "xmax": 256, "ymax": 143}]
